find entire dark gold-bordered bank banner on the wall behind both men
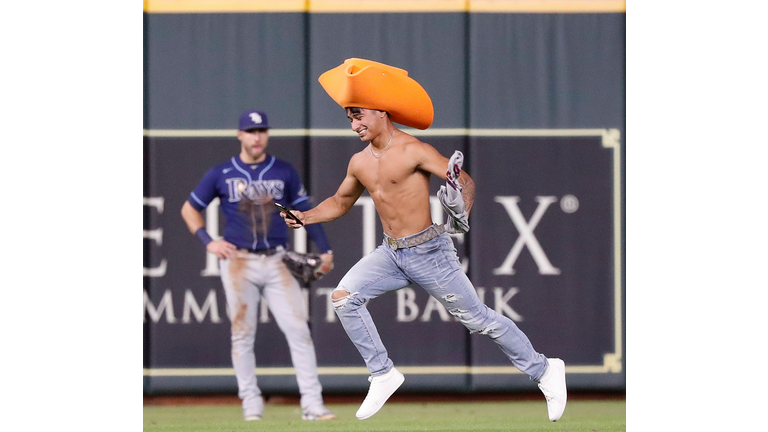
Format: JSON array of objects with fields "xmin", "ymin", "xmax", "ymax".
[{"xmin": 143, "ymin": 129, "xmax": 623, "ymax": 393}]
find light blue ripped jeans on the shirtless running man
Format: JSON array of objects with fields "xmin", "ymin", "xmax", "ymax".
[{"xmin": 334, "ymin": 227, "xmax": 547, "ymax": 381}]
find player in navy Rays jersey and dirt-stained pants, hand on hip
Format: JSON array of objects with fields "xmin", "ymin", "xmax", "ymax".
[{"xmin": 181, "ymin": 110, "xmax": 336, "ymax": 420}]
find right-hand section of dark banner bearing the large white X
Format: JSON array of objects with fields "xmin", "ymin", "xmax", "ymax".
[{"xmin": 470, "ymin": 131, "xmax": 622, "ymax": 390}]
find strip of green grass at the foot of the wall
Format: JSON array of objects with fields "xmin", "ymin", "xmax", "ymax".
[{"xmin": 144, "ymin": 400, "xmax": 627, "ymax": 432}]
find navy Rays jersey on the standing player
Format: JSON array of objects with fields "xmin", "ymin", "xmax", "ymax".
[{"xmin": 188, "ymin": 155, "xmax": 331, "ymax": 253}]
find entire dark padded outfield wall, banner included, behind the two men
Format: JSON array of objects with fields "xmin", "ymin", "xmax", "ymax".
[{"xmin": 143, "ymin": 9, "xmax": 626, "ymax": 394}]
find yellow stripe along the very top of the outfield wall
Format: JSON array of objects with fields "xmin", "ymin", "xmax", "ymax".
[{"xmin": 144, "ymin": 0, "xmax": 627, "ymax": 13}]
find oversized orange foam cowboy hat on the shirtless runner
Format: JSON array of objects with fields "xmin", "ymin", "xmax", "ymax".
[{"xmin": 317, "ymin": 58, "xmax": 435, "ymax": 129}]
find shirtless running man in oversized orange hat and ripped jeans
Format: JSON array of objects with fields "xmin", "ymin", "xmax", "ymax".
[{"xmin": 281, "ymin": 59, "xmax": 567, "ymax": 421}]
